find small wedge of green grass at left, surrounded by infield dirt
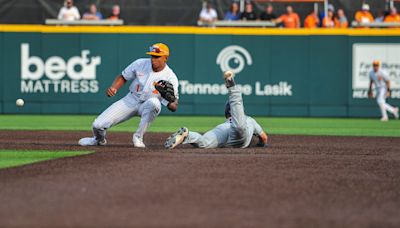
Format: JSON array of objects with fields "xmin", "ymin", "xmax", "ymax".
[{"xmin": 0, "ymin": 150, "xmax": 92, "ymax": 169}]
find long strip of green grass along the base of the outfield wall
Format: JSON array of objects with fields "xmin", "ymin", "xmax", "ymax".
[{"xmin": 0, "ymin": 115, "xmax": 400, "ymax": 137}]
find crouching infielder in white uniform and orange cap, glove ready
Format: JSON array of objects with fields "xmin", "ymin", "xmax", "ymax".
[{"xmin": 79, "ymin": 43, "xmax": 178, "ymax": 148}]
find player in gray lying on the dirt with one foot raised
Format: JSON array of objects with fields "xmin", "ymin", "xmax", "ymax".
[{"xmin": 164, "ymin": 71, "xmax": 268, "ymax": 149}]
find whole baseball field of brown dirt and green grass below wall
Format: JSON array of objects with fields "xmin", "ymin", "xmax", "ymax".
[{"xmin": 0, "ymin": 115, "xmax": 400, "ymax": 227}]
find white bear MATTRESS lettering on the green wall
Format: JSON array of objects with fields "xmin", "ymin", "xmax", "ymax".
[{"xmin": 21, "ymin": 43, "xmax": 101, "ymax": 93}]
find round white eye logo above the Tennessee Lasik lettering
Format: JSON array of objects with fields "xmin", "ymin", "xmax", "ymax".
[{"xmin": 217, "ymin": 45, "xmax": 253, "ymax": 74}]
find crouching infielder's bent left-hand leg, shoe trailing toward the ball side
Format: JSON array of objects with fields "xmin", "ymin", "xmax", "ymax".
[{"xmin": 79, "ymin": 96, "xmax": 138, "ymax": 146}]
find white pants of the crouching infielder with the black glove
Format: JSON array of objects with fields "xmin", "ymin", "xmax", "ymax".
[{"xmin": 92, "ymin": 93, "xmax": 161, "ymax": 141}]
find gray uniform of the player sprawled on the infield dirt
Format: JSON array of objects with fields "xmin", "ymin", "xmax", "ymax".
[{"xmin": 183, "ymin": 86, "xmax": 263, "ymax": 148}]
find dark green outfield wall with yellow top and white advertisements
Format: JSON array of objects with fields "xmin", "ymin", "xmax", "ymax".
[{"xmin": 0, "ymin": 25, "xmax": 400, "ymax": 117}]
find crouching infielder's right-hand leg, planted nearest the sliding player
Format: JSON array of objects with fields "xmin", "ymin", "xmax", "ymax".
[{"xmin": 132, "ymin": 97, "xmax": 161, "ymax": 148}]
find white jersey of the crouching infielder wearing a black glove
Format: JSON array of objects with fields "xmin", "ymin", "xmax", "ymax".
[{"xmin": 122, "ymin": 58, "xmax": 179, "ymax": 106}]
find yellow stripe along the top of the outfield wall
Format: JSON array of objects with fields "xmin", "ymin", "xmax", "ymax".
[{"xmin": 0, "ymin": 25, "xmax": 400, "ymax": 36}]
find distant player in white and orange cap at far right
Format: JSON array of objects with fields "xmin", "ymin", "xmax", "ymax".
[{"xmin": 368, "ymin": 61, "xmax": 399, "ymax": 121}]
